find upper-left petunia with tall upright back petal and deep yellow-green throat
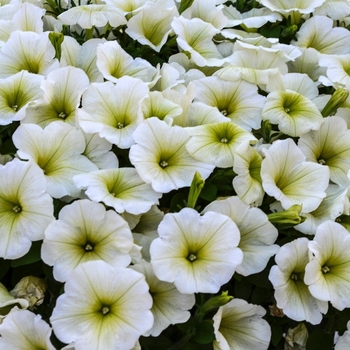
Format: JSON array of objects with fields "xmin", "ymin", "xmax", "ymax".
[{"xmin": 23, "ymin": 67, "xmax": 89, "ymax": 128}]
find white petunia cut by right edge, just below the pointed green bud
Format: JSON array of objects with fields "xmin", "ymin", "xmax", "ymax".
[{"xmin": 298, "ymin": 117, "xmax": 350, "ymax": 186}]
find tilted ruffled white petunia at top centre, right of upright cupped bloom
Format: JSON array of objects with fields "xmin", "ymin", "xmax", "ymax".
[{"xmin": 172, "ymin": 16, "xmax": 228, "ymax": 67}]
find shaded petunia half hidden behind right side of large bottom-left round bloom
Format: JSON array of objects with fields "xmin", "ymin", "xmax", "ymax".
[{"xmin": 132, "ymin": 261, "xmax": 196, "ymax": 337}]
